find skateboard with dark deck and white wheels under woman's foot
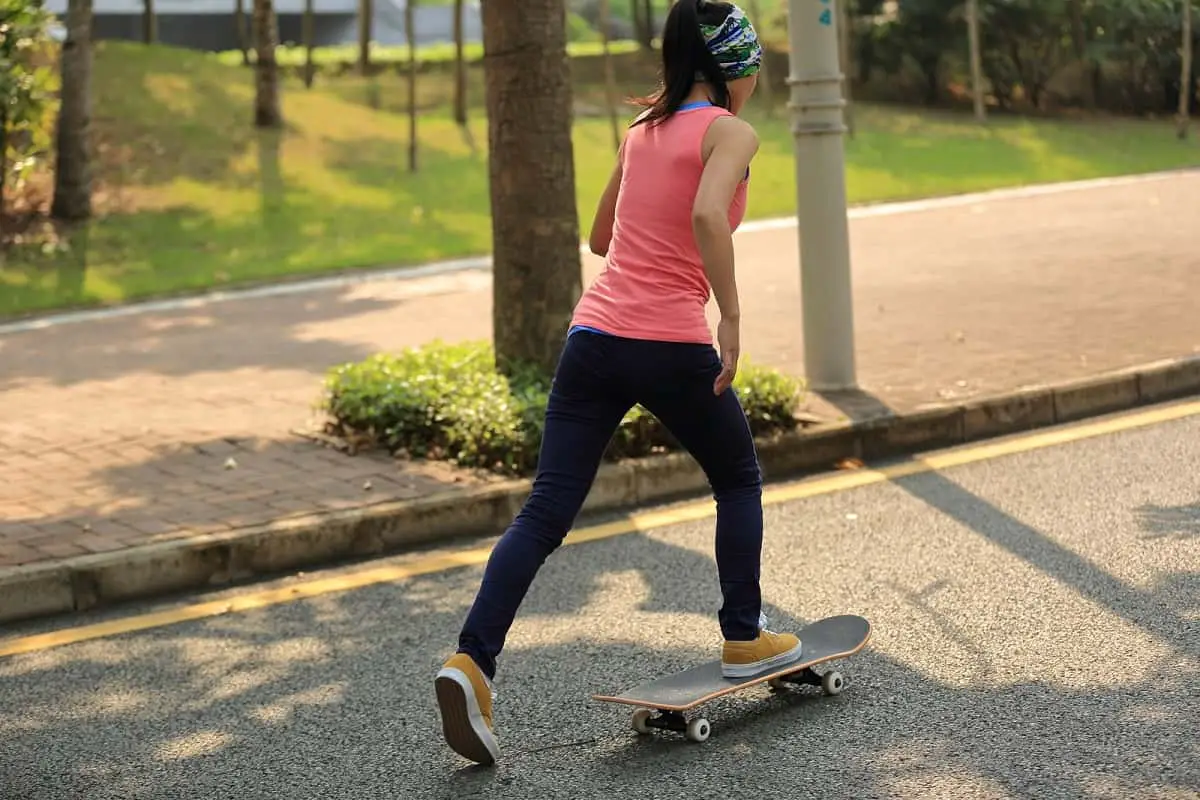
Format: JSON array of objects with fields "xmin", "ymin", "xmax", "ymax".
[{"xmin": 592, "ymin": 614, "xmax": 871, "ymax": 741}]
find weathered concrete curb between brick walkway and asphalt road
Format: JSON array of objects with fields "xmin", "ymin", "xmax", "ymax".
[{"xmin": 0, "ymin": 356, "xmax": 1200, "ymax": 622}]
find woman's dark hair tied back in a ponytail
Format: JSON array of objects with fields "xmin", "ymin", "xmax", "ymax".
[{"xmin": 630, "ymin": 0, "xmax": 733, "ymax": 127}]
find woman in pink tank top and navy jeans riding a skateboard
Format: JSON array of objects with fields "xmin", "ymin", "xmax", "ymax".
[{"xmin": 434, "ymin": 0, "xmax": 800, "ymax": 764}]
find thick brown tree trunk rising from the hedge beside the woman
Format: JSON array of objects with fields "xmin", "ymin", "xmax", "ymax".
[{"xmin": 481, "ymin": 0, "xmax": 582, "ymax": 374}]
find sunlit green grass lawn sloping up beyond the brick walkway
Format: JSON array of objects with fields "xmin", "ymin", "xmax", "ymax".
[{"xmin": 0, "ymin": 42, "xmax": 1200, "ymax": 317}]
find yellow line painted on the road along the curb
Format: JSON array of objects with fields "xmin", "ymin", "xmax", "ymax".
[{"xmin": 0, "ymin": 401, "xmax": 1200, "ymax": 657}]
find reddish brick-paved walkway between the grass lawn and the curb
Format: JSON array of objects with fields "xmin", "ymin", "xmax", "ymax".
[{"xmin": 0, "ymin": 173, "xmax": 1200, "ymax": 567}]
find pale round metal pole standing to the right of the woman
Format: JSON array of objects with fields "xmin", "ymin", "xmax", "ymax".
[{"xmin": 787, "ymin": 0, "xmax": 857, "ymax": 391}]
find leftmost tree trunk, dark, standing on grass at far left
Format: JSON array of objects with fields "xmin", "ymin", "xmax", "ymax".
[{"xmin": 50, "ymin": 0, "xmax": 91, "ymax": 221}]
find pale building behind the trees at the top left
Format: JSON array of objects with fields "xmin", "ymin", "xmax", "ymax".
[{"xmin": 46, "ymin": 0, "xmax": 482, "ymax": 50}]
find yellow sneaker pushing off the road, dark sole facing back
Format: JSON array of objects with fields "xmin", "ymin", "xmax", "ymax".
[{"xmin": 433, "ymin": 652, "xmax": 500, "ymax": 764}]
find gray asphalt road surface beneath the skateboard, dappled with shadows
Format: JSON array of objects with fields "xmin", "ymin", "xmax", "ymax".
[{"xmin": 0, "ymin": 417, "xmax": 1200, "ymax": 800}]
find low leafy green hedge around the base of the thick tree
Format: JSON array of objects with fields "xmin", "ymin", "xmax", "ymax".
[{"xmin": 323, "ymin": 342, "xmax": 802, "ymax": 475}]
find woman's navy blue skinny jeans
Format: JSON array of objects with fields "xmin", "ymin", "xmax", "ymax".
[{"xmin": 458, "ymin": 330, "xmax": 762, "ymax": 678}]
